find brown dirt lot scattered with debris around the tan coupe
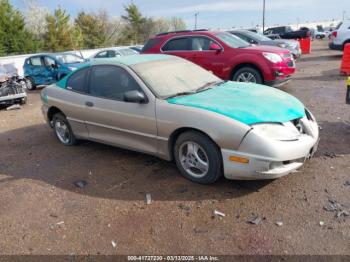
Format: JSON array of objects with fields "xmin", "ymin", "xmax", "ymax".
[{"xmin": 0, "ymin": 41, "xmax": 350, "ymax": 255}]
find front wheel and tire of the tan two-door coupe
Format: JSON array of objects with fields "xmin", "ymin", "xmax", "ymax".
[{"xmin": 174, "ymin": 131, "xmax": 222, "ymax": 184}]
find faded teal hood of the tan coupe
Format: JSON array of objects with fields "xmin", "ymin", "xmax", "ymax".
[{"xmin": 167, "ymin": 82, "xmax": 305, "ymax": 125}]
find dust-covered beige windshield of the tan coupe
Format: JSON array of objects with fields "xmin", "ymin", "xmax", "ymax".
[{"xmin": 132, "ymin": 58, "xmax": 222, "ymax": 99}]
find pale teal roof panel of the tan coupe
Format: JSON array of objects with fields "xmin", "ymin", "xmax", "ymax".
[{"xmin": 91, "ymin": 54, "xmax": 175, "ymax": 66}]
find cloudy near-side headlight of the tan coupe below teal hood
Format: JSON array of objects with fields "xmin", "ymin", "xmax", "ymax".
[{"xmin": 253, "ymin": 123, "xmax": 300, "ymax": 141}]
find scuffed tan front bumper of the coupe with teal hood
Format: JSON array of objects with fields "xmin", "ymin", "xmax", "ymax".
[{"xmin": 221, "ymin": 117, "xmax": 319, "ymax": 180}]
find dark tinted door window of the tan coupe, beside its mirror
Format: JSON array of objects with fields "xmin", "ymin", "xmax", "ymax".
[{"xmin": 90, "ymin": 65, "xmax": 141, "ymax": 101}]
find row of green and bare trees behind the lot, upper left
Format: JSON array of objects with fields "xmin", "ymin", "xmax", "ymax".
[{"xmin": 0, "ymin": 0, "xmax": 186, "ymax": 56}]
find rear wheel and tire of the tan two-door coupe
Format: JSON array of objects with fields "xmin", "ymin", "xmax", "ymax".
[{"xmin": 52, "ymin": 113, "xmax": 77, "ymax": 146}]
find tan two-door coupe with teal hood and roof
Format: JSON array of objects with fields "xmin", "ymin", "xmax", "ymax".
[{"xmin": 41, "ymin": 55, "xmax": 319, "ymax": 184}]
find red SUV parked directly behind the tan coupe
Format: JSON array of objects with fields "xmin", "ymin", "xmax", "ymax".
[{"xmin": 141, "ymin": 30, "xmax": 295, "ymax": 86}]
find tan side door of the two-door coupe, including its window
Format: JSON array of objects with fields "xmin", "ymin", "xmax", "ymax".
[{"xmin": 85, "ymin": 65, "xmax": 157, "ymax": 153}]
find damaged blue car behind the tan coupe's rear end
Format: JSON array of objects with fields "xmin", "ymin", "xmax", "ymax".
[{"xmin": 23, "ymin": 53, "xmax": 87, "ymax": 90}]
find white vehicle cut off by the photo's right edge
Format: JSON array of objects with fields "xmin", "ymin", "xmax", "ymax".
[{"xmin": 329, "ymin": 20, "xmax": 350, "ymax": 50}]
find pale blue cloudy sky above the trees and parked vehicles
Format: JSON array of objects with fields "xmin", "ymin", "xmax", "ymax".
[{"xmin": 10, "ymin": 0, "xmax": 350, "ymax": 28}]
